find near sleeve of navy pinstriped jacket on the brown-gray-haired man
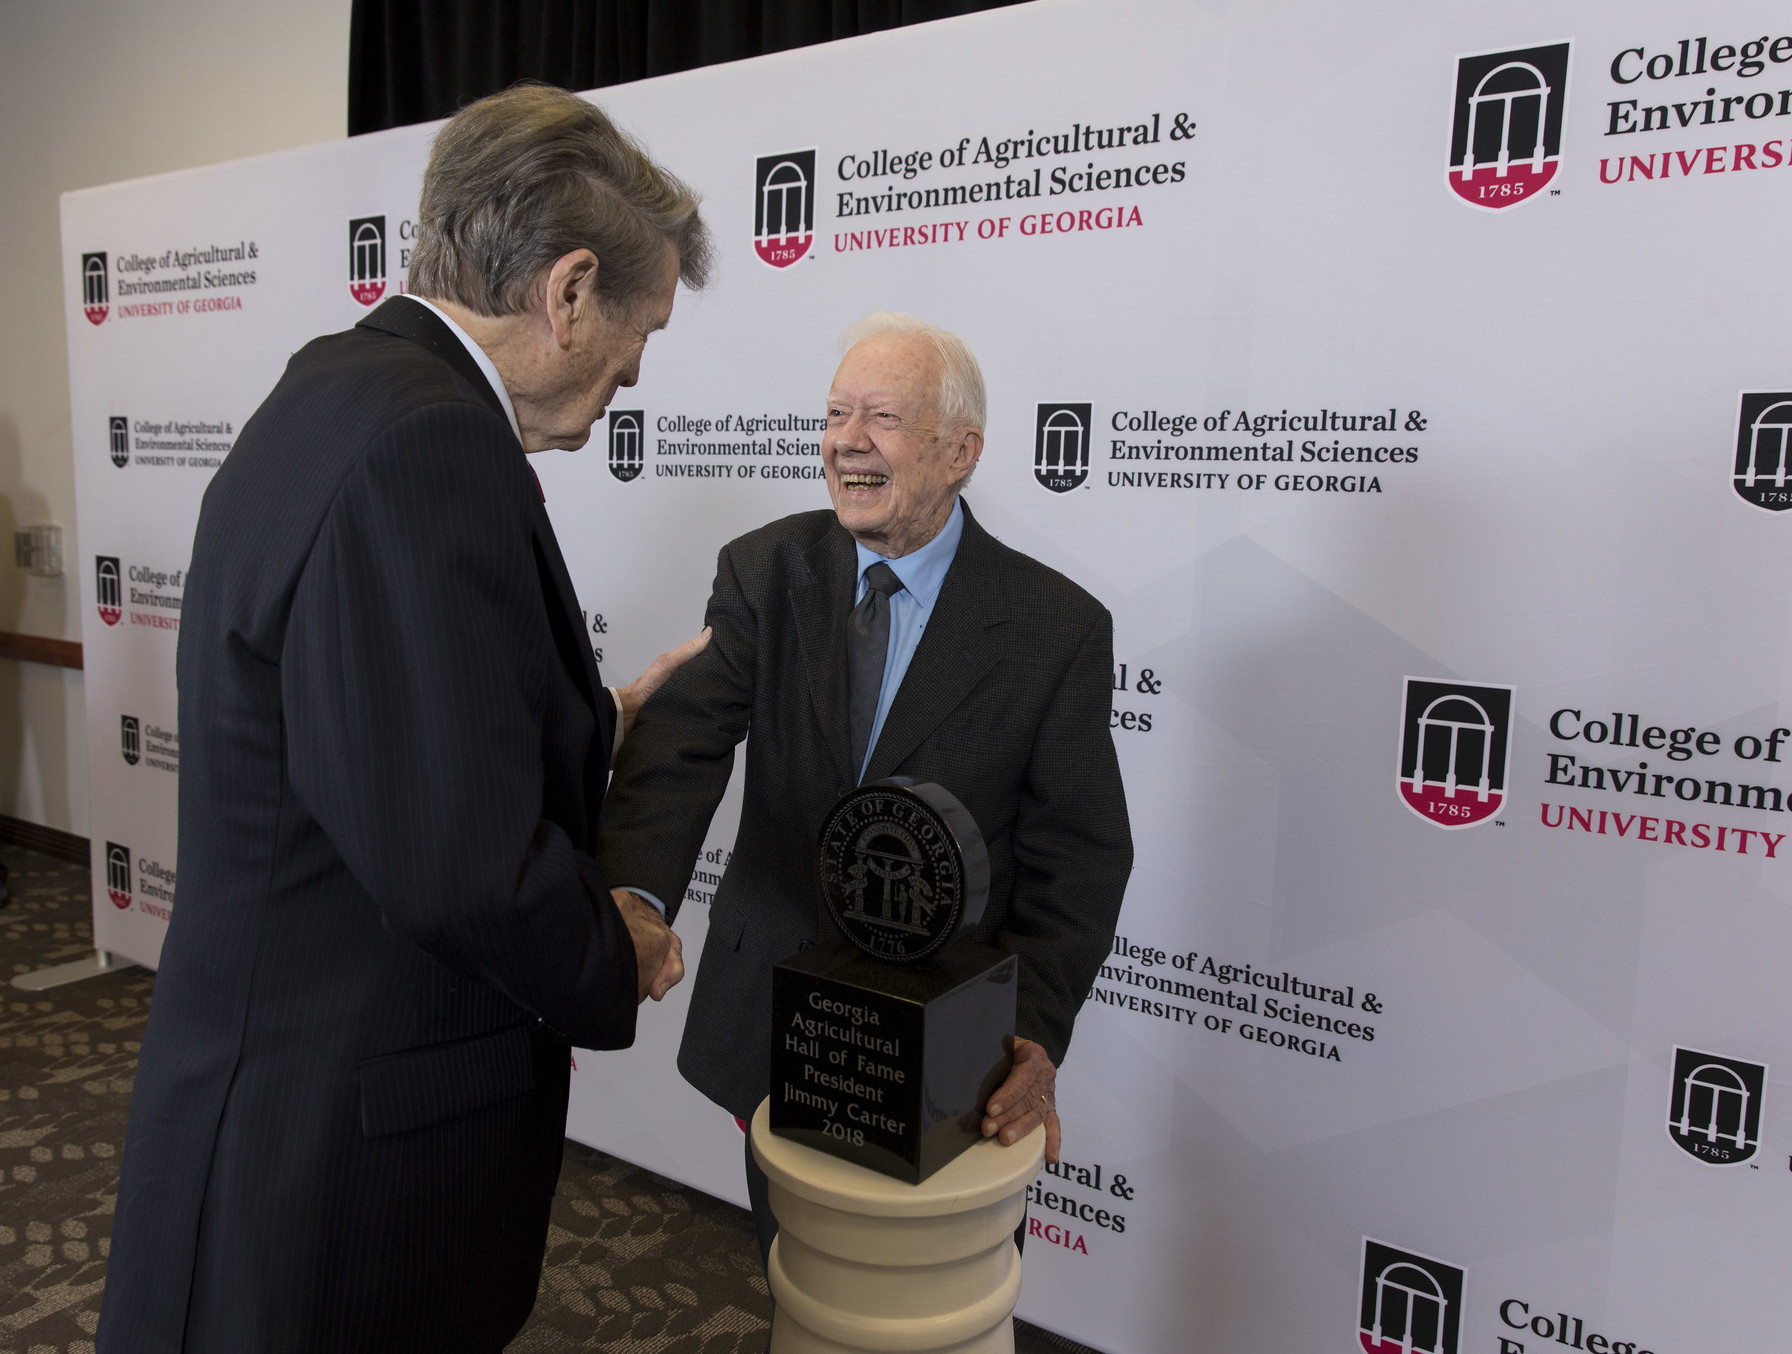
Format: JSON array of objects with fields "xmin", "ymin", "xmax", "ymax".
[{"xmin": 280, "ymin": 403, "xmax": 636, "ymax": 1048}]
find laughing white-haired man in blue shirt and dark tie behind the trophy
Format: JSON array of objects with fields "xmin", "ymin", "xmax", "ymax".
[{"xmin": 600, "ymin": 312, "xmax": 1133, "ymax": 1254}]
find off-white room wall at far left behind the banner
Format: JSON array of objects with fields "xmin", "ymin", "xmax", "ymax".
[{"xmin": 0, "ymin": 0, "xmax": 349, "ymax": 835}]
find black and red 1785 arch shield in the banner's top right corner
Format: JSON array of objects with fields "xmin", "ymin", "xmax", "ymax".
[{"xmin": 1450, "ymin": 43, "xmax": 1568, "ymax": 211}]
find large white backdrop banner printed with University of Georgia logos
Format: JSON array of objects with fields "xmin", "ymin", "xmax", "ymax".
[{"xmin": 63, "ymin": 0, "xmax": 1792, "ymax": 1354}]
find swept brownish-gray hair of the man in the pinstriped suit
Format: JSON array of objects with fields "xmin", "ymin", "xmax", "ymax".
[{"xmin": 409, "ymin": 84, "xmax": 711, "ymax": 315}]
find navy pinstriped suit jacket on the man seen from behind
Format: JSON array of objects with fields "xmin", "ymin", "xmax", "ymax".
[{"xmin": 99, "ymin": 299, "xmax": 634, "ymax": 1354}]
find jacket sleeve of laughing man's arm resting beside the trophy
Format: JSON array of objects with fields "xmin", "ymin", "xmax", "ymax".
[{"xmin": 995, "ymin": 611, "xmax": 1133, "ymax": 1064}]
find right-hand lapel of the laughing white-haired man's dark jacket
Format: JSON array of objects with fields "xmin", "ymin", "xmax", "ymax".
[{"xmin": 860, "ymin": 507, "xmax": 1007, "ymax": 781}]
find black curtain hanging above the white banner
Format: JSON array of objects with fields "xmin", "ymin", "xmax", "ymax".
[{"xmin": 348, "ymin": 0, "xmax": 1018, "ymax": 136}]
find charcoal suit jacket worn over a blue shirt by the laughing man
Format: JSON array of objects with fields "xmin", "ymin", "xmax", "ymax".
[{"xmin": 602, "ymin": 505, "xmax": 1133, "ymax": 1118}]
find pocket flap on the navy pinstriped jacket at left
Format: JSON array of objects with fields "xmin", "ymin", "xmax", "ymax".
[{"xmin": 360, "ymin": 1024, "xmax": 536, "ymax": 1137}]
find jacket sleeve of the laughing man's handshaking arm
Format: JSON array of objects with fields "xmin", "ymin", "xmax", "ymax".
[{"xmin": 600, "ymin": 546, "xmax": 758, "ymax": 921}]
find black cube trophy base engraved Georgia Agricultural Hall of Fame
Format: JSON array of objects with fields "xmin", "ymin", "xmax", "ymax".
[{"xmin": 771, "ymin": 938, "xmax": 1020, "ymax": 1184}]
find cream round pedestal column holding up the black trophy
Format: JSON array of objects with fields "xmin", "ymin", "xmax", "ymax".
[{"xmin": 753, "ymin": 1101, "xmax": 1045, "ymax": 1354}]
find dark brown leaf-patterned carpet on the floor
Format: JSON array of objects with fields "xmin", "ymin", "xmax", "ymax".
[{"xmin": 0, "ymin": 845, "xmax": 1082, "ymax": 1354}]
